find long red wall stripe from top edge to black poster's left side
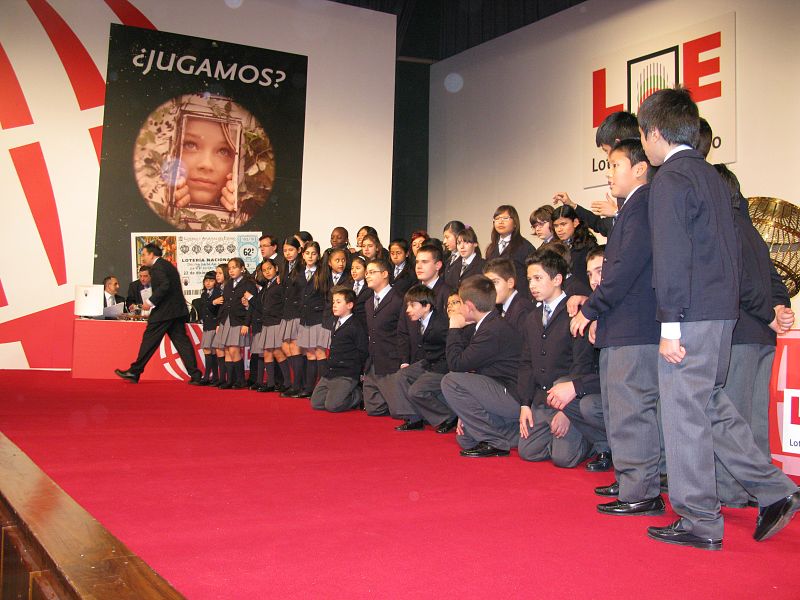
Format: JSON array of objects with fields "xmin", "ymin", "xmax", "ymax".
[{"xmin": 28, "ymin": 0, "xmax": 106, "ymax": 110}]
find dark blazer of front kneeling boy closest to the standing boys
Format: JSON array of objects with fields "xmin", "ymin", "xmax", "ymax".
[{"xmin": 519, "ymin": 298, "xmax": 600, "ymax": 406}]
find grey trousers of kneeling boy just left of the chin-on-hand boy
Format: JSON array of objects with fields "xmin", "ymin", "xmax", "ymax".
[{"xmin": 393, "ymin": 362, "xmax": 455, "ymax": 427}]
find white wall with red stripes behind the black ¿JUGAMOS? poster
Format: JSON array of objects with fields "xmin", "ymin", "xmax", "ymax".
[{"xmin": 0, "ymin": 0, "xmax": 396, "ymax": 368}]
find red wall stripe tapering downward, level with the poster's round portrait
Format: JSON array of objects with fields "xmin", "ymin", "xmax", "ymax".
[{"xmin": 8, "ymin": 142, "xmax": 67, "ymax": 285}]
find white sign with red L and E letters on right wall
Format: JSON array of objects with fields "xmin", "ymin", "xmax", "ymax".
[{"xmin": 581, "ymin": 13, "xmax": 736, "ymax": 188}]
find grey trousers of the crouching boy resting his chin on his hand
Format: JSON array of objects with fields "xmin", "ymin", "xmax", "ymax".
[{"xmin": 442, "ymin": 373, "xmax": 519, "ymax": 450}]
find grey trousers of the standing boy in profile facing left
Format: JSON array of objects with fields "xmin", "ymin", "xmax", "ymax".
[{"xmin": 600, "ymin": 344, "xmax": 661, "ymax": 502}]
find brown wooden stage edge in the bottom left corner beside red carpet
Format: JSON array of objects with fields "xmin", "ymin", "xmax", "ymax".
[{"xmin": 0, "ymin": 433, "xmax": 183, "ymax": 600}]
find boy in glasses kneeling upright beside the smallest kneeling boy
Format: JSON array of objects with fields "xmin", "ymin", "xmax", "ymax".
[{"xmin": 363, "ymin": 258, "xmax": 403, "ymax": 417}]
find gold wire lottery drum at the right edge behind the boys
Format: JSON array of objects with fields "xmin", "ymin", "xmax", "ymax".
[{"xmin": 747, "ymin": 196, "xmax": 800, "ymax": 297}]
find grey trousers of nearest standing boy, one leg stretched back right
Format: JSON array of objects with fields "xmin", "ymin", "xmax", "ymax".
[{"xmin": 658, "ymin": 321, "xmax": 797, "ymax": 539}]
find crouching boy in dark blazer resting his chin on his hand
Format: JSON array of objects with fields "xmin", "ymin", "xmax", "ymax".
[{"xmin": 442, "ymin": 275, "xmax": 522, "ymax": 458}]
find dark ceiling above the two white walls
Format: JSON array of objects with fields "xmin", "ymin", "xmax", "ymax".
[{"xmin": 333, "ymin": 0, "xmax": 584, "ymax": 62}]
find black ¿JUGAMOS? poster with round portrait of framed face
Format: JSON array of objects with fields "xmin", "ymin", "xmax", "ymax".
[{"xmin": 94, "ymin": 24, "xmax": 308, "ymax": 279}]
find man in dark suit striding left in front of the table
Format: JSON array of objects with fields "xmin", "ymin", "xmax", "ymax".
[{"xmin": 114, "ymin": 243, "xmax": 202, "ymax": 385}]
